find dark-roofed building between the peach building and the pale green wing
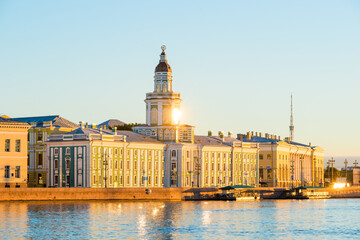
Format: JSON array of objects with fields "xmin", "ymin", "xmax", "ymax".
[{"xmin": 13, "ymin": 115, "xmax": 78, "ymax": 187}]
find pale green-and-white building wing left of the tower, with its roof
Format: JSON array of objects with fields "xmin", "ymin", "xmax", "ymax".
[{"xmin": 47, "ymin": 126, "xmax": 165, "ymax": 188}]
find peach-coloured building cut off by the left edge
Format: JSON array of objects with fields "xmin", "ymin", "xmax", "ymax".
[{"xmin": 0, "ymin": 117, "xmax": 30, "ymax": 187}]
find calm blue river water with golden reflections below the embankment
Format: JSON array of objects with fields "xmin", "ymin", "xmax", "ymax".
[{"xmin": 0, "ymin": 199, "xmax": 360, "ymax": 239}]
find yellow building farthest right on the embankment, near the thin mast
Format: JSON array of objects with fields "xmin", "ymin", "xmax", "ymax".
[{"xmin": 238, "ymin": 132, "xmax": 324, "ymax": 187}]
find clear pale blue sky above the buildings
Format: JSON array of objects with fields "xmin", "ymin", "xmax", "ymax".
[{"xmin": 0, "ymin": 0, "xmax": 360, "ymax": 168}]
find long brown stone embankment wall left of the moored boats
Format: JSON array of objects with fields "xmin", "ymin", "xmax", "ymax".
[{"xmin": 0, "ymin": 188, "xmax": 197, "ymax": 201}]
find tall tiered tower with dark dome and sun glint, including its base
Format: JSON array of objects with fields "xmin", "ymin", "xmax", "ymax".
[{"xmin": 133, "ymin": 45, "xmax": 194, "ymax": 143}]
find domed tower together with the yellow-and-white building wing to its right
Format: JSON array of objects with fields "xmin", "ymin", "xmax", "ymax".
[{"xmin": 133, "ymin": 46, "xmax": 258, "ymax": 187}]
